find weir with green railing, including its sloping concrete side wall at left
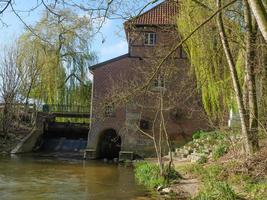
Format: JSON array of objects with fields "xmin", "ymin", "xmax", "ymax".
[{"xmin": 11, "ymin": 105, "xmax": 90, "ymax": 155}]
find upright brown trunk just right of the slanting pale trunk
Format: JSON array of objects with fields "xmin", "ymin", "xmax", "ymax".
[{"xmin": 243, "ymin": 0, "xmax": 259, "ymax": 151}]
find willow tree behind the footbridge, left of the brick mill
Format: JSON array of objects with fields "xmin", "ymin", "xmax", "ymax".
[{"xmin": 19, "ymin": 9, "xmax": 94, "ymax": 104}]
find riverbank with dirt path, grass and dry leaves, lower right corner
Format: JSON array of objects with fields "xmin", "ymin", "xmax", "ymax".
[{"xmin": 137, "ymin": 135, "xmax": 267, "ymax": 200}]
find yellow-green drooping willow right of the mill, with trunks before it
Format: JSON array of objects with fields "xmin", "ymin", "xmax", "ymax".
[{"xmin": 178, "ymin": 0, "xmax": 266, "ymax": 155}]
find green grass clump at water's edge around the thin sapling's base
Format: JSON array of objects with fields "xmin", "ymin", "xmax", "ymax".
[{"xmin": 134, "ymin": 162, "xmax": 179, "ymax": 188}]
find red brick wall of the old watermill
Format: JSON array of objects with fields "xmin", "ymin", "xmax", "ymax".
[{"xmin": 91, "ymin": 24, "xmax": 210, "ymax": 154}]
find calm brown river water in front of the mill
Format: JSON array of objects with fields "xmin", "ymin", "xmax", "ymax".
[{"xmin": 0, "ymin": 156, "xmax": 150, "ymax": 200}]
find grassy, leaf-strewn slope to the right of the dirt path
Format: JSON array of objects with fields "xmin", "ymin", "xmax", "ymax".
[{"xmin": 176, "ymin": 146, "xmax": 267, "ymax": 200}]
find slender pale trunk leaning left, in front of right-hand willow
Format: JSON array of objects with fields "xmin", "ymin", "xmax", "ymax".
[{"xmin": 217, "ymin": 0, "xmax": 253, "ymax": 155}]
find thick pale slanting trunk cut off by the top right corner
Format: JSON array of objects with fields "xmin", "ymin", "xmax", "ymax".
[{"xmin": 248, "ymin": 0, "xmax": 267, "ymax": 42}]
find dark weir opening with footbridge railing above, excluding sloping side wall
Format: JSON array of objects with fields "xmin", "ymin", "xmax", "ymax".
[{"xmin": 35, "ymin": 104, "xmax": 90, "ymax": 152}]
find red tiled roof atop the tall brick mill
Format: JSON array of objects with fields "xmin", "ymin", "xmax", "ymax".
[{"xmin": 125, "ymin": 0, "xmax": 178, "ymax": 25}]
